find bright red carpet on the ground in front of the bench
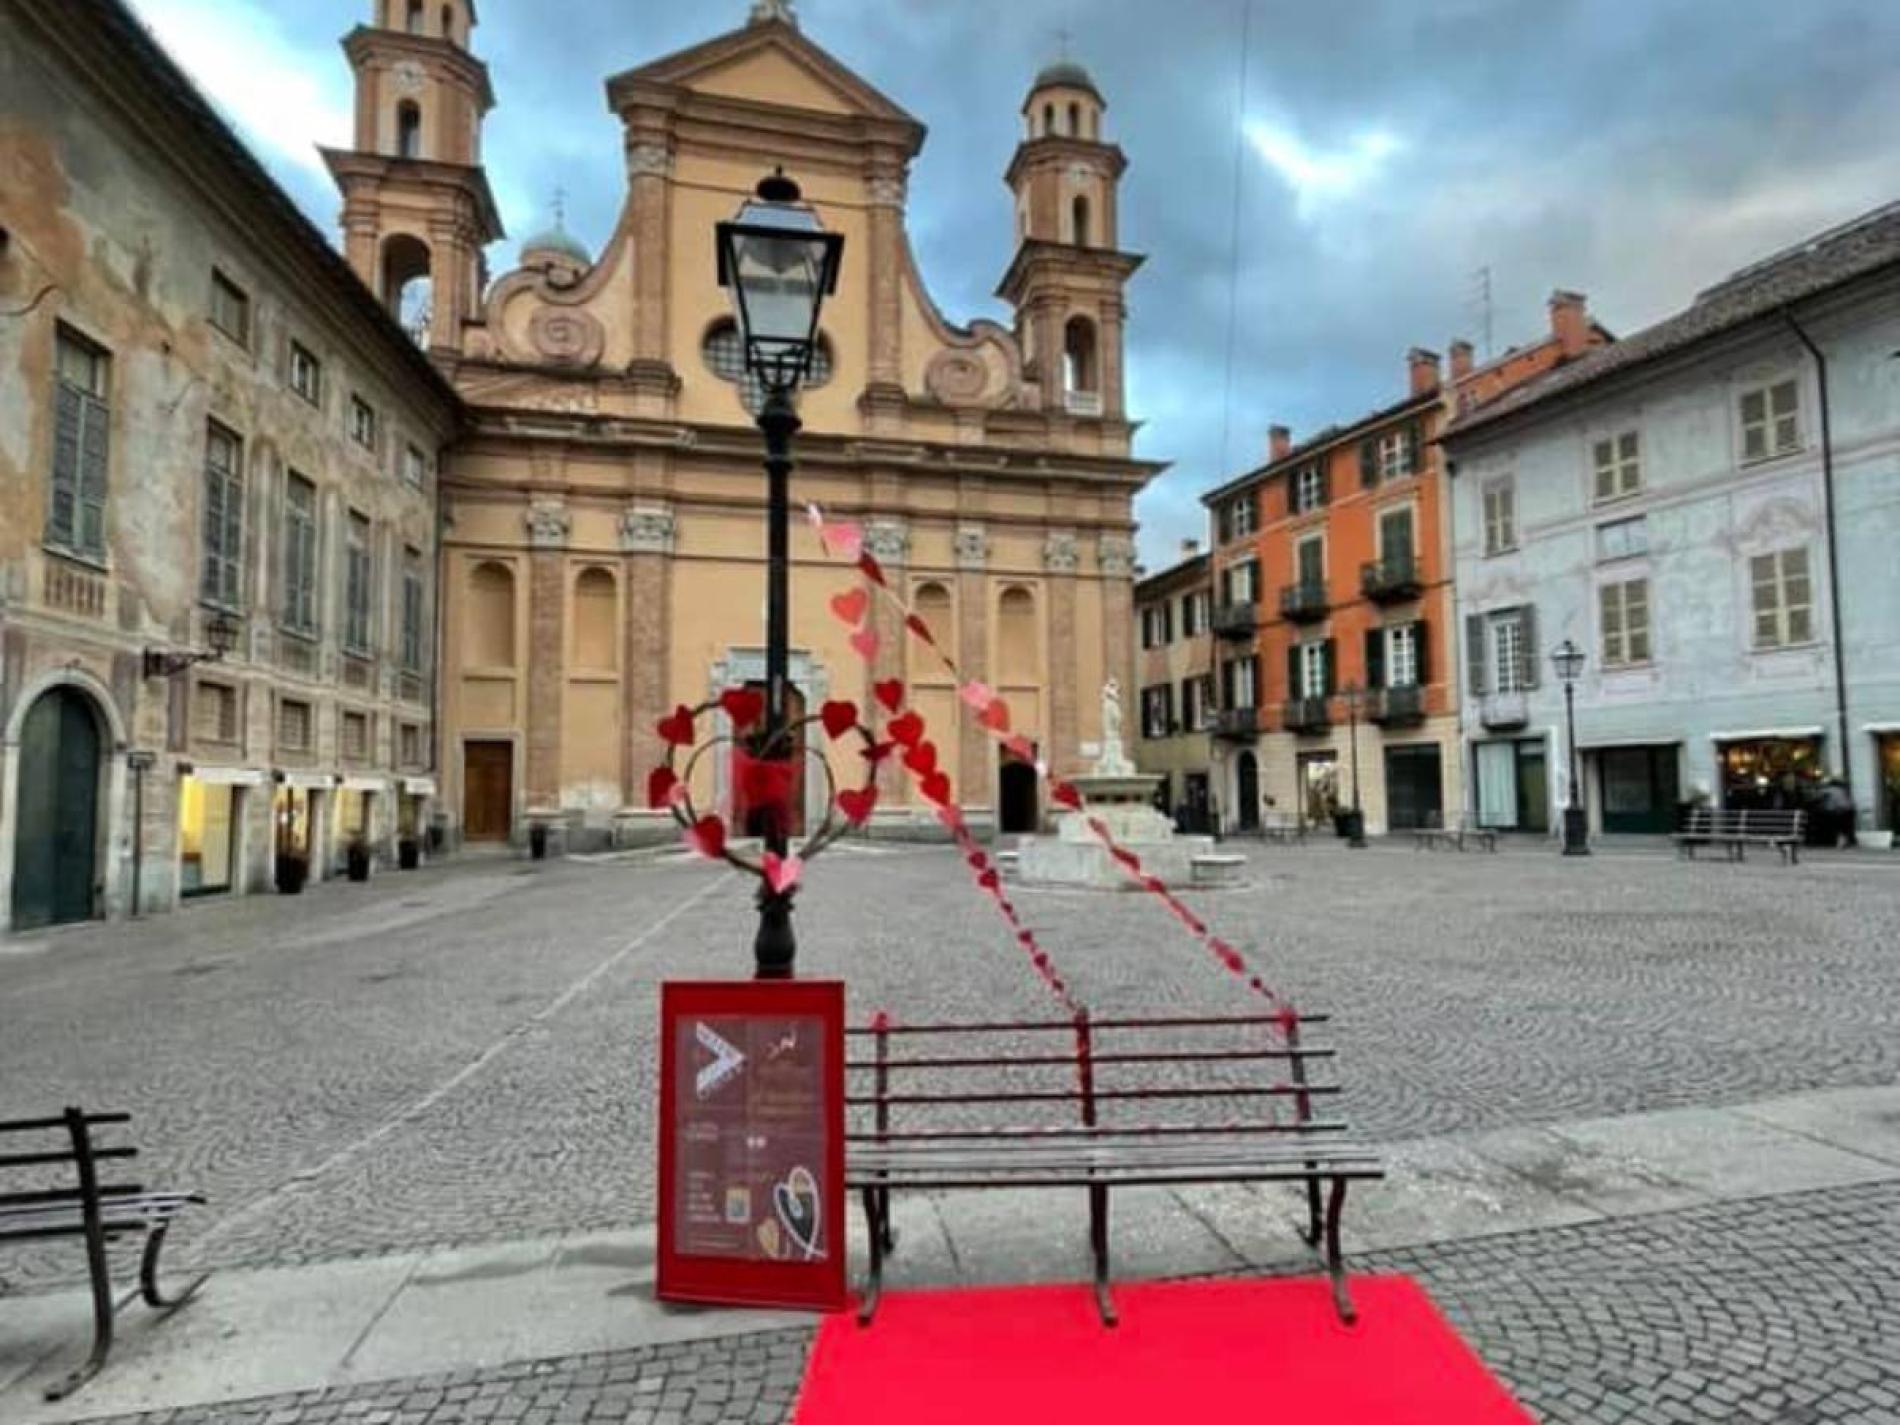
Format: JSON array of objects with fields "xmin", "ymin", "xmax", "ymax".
[{"xmin": 794, "ymin": 1277, "xmax": 1531, "ymax": 1425}]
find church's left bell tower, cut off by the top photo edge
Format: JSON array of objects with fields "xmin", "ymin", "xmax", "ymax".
[{"xmin": 323, "ymin": 0, "xmax": 504, "ymax": 355}]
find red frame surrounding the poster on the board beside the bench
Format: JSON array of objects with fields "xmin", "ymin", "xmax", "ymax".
[{"xmin": 654, "ymin": 980, "xmax": 849, "ymax": 1311}]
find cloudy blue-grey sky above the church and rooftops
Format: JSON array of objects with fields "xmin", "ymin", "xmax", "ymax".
[{"xmin": 133, "ymin": 0, "xmax": 1900, "ymax": 566}]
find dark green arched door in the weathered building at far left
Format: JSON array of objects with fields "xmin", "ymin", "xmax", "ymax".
[{"xmin": 13, "ymin": 688, "xmax": 101, "ymax": 929}]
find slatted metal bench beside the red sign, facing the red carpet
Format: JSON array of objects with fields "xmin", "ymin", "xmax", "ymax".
[{"xmin": 846, "ymin": 1015, "xmax": 1385, "ymax": 1326}]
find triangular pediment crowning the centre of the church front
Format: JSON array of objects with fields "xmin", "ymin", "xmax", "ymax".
[{"xmin": 608, "ymin": 21, "xmax": 918, "ymax": 125}]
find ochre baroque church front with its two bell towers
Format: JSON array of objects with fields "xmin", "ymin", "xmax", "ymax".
[{"xmin": 327, "ymin": 0, "xmax": 1161, "ymax": 846}]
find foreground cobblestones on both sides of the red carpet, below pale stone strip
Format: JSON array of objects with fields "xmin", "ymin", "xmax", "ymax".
[{"xmin": 59, "ymin": 1186, "xmax": 1900, "ymax": 1425}]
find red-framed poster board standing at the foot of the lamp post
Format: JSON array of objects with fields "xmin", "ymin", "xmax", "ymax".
[{"xmin": 657, "ymin": 980, "xmax": 846, "ymax": 1311}]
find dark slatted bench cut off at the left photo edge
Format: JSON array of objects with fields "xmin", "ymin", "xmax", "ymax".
[{"xmin": 0, "ymin": 1108, "xmax": 205, "ymax": 1400}]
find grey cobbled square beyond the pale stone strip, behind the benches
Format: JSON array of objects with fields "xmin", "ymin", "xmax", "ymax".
[{"xmin": 0, "ymin": 842, "xmax": 1900, "ymax": 1290}]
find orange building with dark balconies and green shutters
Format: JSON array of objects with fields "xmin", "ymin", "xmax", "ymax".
[{"xmin": 1203, "ymin": 293, "xmax": 1611, "ymax": 832}]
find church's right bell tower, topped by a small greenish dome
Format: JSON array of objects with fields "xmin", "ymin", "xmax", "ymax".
[{"xmin": 998, "ymin": 61, "xmax": 1142, "ymax": 422}]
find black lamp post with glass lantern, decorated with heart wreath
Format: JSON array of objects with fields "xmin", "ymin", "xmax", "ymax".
[{"xmin": 718, "ymin": 169, "xmax": 844, "ymax": 980}]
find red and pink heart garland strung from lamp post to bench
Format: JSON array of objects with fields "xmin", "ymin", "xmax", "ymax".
[{"xmin": 806, "ymin": 504, "xmax": 1298, "ymax": 1034}]
